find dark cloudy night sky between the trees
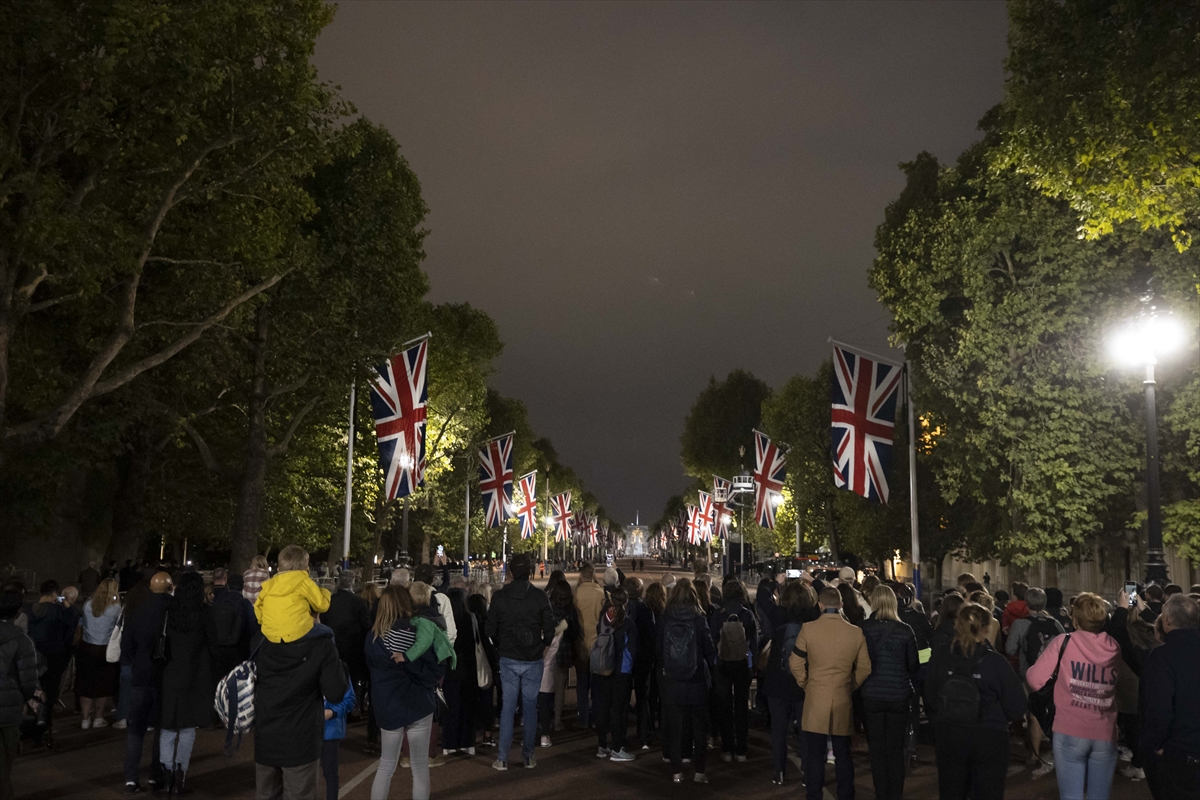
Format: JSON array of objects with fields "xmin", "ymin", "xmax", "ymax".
[{"xmin": 316, "ymin": 0, "xmax": 1006, "ymax": 521}]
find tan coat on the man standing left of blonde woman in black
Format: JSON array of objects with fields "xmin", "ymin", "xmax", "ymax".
[{"xmin": 787, "ymin": 614, "xmax": 871, "ymax": 736}]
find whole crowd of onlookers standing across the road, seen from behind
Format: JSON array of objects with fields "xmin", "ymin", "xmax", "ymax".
[{"xmin": 0, "ymin": 546, "xmax": 1200, "ymax": 800}]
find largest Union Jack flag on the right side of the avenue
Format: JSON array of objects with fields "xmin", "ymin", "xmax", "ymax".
[{"xmin": 832, "ymin": 344, "xmax": 904, "ymax": 503}]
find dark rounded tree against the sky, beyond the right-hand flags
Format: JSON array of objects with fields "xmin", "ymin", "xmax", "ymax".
[{"xmin": 679, "ymin": 369, "xmax": 770, "ymax": 483}]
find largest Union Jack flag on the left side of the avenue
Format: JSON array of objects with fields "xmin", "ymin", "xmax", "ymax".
[{"xmin": 371, "ymin": 339, "xmax": 430, "ymax": 500}]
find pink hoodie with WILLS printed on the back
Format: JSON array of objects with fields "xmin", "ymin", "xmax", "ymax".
[{"xmin": 1027, "ymin": 631, "xmax": 1121, "ymax": 741}]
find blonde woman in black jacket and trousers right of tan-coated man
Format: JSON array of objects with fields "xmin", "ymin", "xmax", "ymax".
[{"xmin": 862, "ymin": 585, "xmax": 920, "ymax": 800}]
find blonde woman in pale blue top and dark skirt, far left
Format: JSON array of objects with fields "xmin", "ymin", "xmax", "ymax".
[{"xmin": 76, "ymin": 578, "xmax": 121, "ymax": 730}]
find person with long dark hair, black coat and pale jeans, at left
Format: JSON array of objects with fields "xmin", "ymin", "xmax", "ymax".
[{"xmin": 158, "ymin": 572, "xmax": 216, "ymax": 794}]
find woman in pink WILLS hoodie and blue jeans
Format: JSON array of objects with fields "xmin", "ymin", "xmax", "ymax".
[{"xmin": 1026, "ymin": 591, "xmax": 1121, "ymax": 800}]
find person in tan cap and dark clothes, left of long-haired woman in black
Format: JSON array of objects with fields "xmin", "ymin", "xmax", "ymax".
[{"xmin": 121, "ymin": 572, "xmax": 173, "ymax": 794}]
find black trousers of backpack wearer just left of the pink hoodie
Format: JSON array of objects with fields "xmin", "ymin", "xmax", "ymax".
[{"xmin": 934, "ymin": 720, "xmax": 1008, "ymax": 800}]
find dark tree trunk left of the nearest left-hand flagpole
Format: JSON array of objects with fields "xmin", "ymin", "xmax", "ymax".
[{"xmin": 229, "ymin": 303, "xmax": 268, "ymax": 573}]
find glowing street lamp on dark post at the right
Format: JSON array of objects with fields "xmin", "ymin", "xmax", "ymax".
[{"xmin": 1109, "ymin": 306, "xmax": 1187, "ymax": 585}]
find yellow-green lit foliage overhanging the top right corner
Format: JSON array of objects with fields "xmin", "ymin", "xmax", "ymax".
[{"xmin": 995, "ymin": 0, "xmax": 1200, "ymax": 248}]
